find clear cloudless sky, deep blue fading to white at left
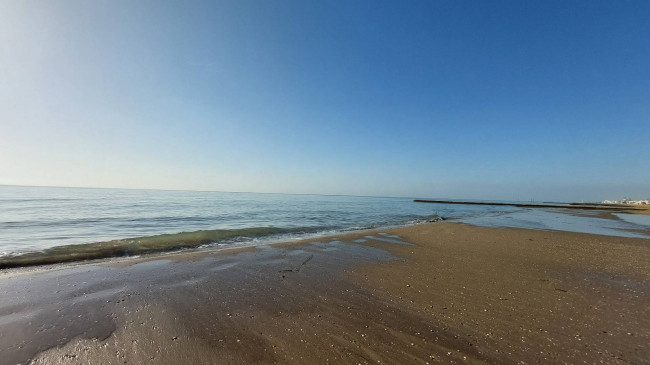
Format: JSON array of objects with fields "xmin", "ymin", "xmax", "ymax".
[{"xmin": 0, "ymin": 0, "xmax": 650, "ymax": 201}]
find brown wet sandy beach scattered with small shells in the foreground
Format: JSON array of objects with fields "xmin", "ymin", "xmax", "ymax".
[{"xmin": 0, "ymin": 222, "xmax": 650, "ymax": 364}]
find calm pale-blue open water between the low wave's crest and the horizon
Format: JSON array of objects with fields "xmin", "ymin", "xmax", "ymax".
[{"xmin": 0, "ymin": 186, "xmax": 504, "ymax": 256}]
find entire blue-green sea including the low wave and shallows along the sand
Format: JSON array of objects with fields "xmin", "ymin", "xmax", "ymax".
[{"xmin": 0, "ymin": 186, "xmax": 650, "ymax": 268}]
